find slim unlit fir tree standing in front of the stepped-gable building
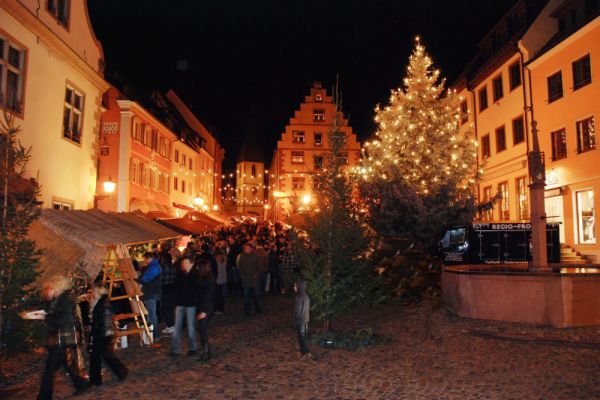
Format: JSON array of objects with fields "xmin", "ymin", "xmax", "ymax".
[{"xmin": 293, "ymin": 94, "xmax": 377, "ymax": 331}]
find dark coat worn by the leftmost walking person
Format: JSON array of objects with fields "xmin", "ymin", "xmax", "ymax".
[{"xmin": 46, "ymin": 291, "xmax": 77, "ymax": 347}]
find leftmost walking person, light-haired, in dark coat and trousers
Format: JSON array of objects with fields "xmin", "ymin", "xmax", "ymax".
[{"xmin": 38, "ymin": 276, "xmax": 89, "ymax": 400}]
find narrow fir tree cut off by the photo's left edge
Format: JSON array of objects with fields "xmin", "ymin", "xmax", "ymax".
[{"xmin": 0, "ymin": 112, "xmax": 41, "ymax": 357}]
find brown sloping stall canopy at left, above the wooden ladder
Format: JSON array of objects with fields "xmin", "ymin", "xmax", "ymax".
[{"xmin": 29, "ymin": 209, "xmax": 181, "ymax": 281}]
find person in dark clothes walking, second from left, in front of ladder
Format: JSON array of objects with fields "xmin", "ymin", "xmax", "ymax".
[{"xmin": 90, "ymin": 283, "xmax": 129, "ymax": 386}]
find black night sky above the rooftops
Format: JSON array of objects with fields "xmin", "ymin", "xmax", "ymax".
[{"xmin": 88, "ymin": 0, "xmax": 516, "ymax": 170}]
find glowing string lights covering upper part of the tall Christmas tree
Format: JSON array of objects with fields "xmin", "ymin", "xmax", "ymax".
[{"xmin": 359, "ymin": 37, "xmax": 477, "ymax": 194}]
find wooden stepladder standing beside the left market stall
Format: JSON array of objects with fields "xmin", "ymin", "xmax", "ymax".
[{"xmin": 102, "ymin": 244, "xmax": 158, "ymax": 345}]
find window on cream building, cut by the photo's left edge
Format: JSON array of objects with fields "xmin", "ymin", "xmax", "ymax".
[{"xmin": 0, "ymin": 36, "xmax": 25, "ymax": 113}]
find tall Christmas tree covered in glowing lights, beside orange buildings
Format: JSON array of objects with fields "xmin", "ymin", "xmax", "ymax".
[{"xmin": 361, "ymin": 38, "xmax": 477, "ymax": 248}]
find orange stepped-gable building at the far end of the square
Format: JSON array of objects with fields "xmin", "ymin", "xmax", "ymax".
[{"xmin": 269, "ymin": 82, "xmax": 360, "ymax": 220}]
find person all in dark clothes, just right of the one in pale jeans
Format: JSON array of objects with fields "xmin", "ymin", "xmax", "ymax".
[{"xmin": 194, "ymin": 258, "xmax": 215, "ymax": 361}]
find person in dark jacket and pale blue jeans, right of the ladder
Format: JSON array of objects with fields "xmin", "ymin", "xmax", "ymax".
[{"xmin": 171, "ymin": 257, "xmax": 200, "ymax": 356}]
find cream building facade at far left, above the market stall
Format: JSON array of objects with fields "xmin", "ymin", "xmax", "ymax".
[{"xmin": 0, "ymin": 0, "xmax": 109, "ymax": 209}]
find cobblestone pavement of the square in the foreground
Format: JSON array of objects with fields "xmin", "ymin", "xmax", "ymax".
[{"xmin": 0, "ymin": 297, "xmax": 600, "ymax": 400}]
